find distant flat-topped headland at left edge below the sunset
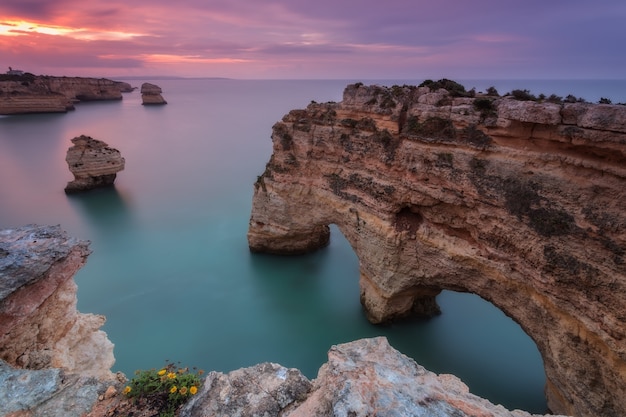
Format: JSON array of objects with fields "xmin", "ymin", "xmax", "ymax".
[{"xmin": 0, "ymin": 74, "xmax": 132, "ymax": 115}]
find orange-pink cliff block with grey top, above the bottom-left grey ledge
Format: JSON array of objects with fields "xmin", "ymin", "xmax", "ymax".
[{"xmin": 0, "ymin": 225, "xmax": 114, "ymax": 377}]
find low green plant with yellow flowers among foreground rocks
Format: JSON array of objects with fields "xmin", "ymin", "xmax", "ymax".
[{"xmin": 124, "ymin": 363, "xmax": 203, "ymax": 417}]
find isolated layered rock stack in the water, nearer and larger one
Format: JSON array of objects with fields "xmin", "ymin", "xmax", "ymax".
[{"xmin": 65, "ymin": 135, "xmax": 125, "ymax": 194}]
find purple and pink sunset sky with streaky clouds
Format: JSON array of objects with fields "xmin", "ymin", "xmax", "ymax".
[{"xmin": 0, "ymin": 0, "xmax": 626, "ymax": 79}]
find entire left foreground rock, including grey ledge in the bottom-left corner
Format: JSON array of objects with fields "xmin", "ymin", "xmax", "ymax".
[{"xmin": 0, "ymin": 225, "xmax": 120, "ymax": 417}]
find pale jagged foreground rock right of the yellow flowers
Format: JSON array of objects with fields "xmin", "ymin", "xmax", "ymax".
[{"xmin": 180, "ymin": 337, "xmax": 560, "ymax": 417}]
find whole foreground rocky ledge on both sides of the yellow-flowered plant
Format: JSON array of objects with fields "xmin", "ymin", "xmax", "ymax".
[{"xmin": 0, "ymin": 225, "xmax": 556, "ymax": 417}]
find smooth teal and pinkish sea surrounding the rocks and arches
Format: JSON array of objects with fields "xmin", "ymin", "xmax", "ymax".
[{"xmin": 0, "ymin": 77, "xmax": 626, "ymax": 413}]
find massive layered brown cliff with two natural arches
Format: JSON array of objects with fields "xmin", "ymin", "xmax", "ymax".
[{"xmin": 248, "ymin": 84, "xmax": 626, "ymax": 417}]
